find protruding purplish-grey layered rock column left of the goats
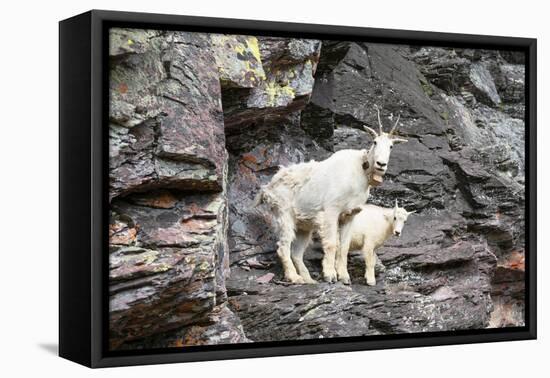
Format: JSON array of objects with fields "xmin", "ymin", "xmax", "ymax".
[{"xmin": 109, "ymin": 29, "xmax": 248, "ymax": 349}]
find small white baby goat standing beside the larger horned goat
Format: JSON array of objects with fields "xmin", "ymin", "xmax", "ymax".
[{"xmin": 336, "ymin": 200, "xmax": 414, "ymax": 285}]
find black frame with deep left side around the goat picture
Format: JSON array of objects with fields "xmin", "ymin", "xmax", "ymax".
[{"xmin": 59, "ymin": 10, "xmax": 537, "ymax": 367}]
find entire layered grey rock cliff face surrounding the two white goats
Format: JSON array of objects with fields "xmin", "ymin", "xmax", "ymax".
[{"xmin": 109, "ymin": 29, "xmax": 525, "ymax": 349}]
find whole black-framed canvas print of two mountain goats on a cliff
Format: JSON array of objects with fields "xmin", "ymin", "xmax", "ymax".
[{"xmin": 59, "ymin": 11, "xmax": 536, "ymax": 367}]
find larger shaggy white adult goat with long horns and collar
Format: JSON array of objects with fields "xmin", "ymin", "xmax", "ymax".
[{"xmin": 257, "ymin": 107, "xmax": 407, "ymax": 283}]
